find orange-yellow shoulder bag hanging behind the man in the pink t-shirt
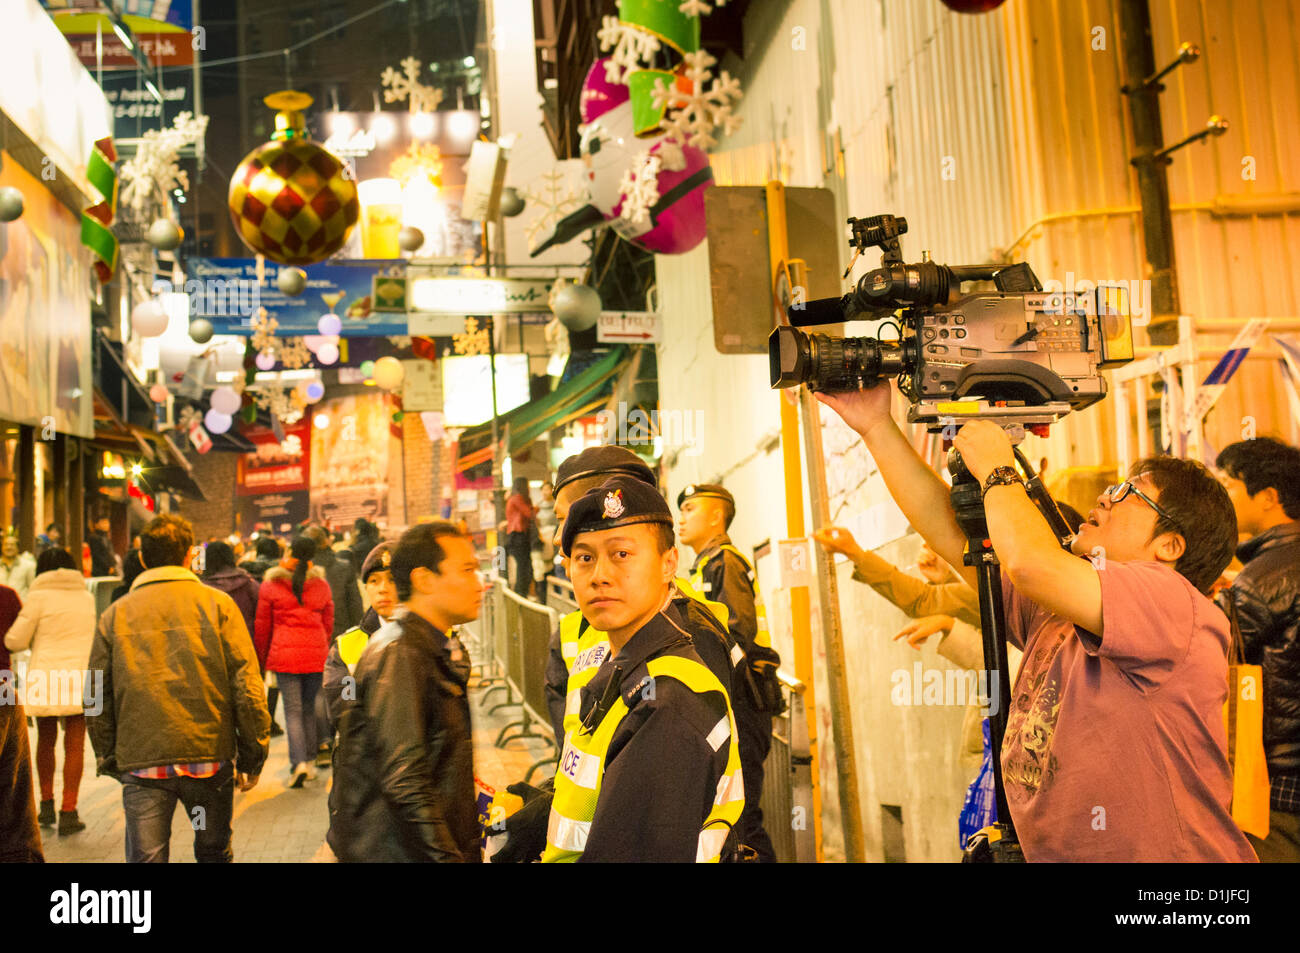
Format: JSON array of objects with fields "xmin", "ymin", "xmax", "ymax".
[{"xmin": 1223, "ymin": 598, "xmax": 1269, "ymax": 840}]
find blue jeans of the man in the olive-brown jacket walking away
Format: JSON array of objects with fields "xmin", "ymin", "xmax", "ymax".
[{"xmin": 121, "ymin": 762, "xmax": 235, "ymax": 863}]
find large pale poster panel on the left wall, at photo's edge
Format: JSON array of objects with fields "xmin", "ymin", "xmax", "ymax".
[{"xmin": 0, "ymin": 152, "xmax": 94, "ymax": 437}]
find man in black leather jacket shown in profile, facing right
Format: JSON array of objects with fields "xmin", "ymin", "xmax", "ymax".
[{"xmin": 328, "ymin": 521, "xmax": 484, "ymax": 863}]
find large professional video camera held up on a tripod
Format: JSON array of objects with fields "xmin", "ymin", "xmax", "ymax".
[{"xmin": 767, "ymin": 215, "xmax": 1134, "ymax": 433}]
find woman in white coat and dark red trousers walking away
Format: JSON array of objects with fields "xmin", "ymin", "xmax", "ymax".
[{"xmin": 4, "ymin": 549, "xmax": 101, "ymax": 835}]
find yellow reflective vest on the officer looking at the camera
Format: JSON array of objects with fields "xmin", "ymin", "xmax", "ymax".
[{"xmin": 542, "ymin": 655, "xmax": 745, "ymax": 863}]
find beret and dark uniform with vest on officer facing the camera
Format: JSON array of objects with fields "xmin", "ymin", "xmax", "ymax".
[{"xmin": 542, "ymin": 477, "xmax": 744, "ymax": 862}]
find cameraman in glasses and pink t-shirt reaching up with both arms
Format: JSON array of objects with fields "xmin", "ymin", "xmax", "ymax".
[{"xmin": 816, "ymin": 384, "xmax": 1256, "ymax": 862}]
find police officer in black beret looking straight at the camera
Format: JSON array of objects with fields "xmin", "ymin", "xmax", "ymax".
[{"xmin": 542, "ymin": 476, "xmax": 745, "ymax": 862}]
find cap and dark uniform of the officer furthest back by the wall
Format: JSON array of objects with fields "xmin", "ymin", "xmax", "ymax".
[{"xmin": 677, "ymin": 484, "xmax": 780, "ymax": 862}]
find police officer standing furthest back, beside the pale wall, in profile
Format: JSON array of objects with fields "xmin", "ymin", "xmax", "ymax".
[{"xmin": 677, "ymin": 484, "xmax": 781, "ymax": 862}]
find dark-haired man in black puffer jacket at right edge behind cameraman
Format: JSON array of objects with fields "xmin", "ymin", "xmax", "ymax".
[{"xmin": 1216, "ymin": 437, "xmax": 1300, "ymax": 863}]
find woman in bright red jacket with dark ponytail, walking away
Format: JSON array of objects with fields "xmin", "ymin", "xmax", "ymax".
[{"xmin": 254, "ymin": 536, "xmax": 334, "ymax": 788}]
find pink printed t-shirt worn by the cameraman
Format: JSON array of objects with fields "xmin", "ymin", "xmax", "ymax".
[{"xmin": 1002, "ymin": 562, "xmax": 1256, "ymax": 862}]
